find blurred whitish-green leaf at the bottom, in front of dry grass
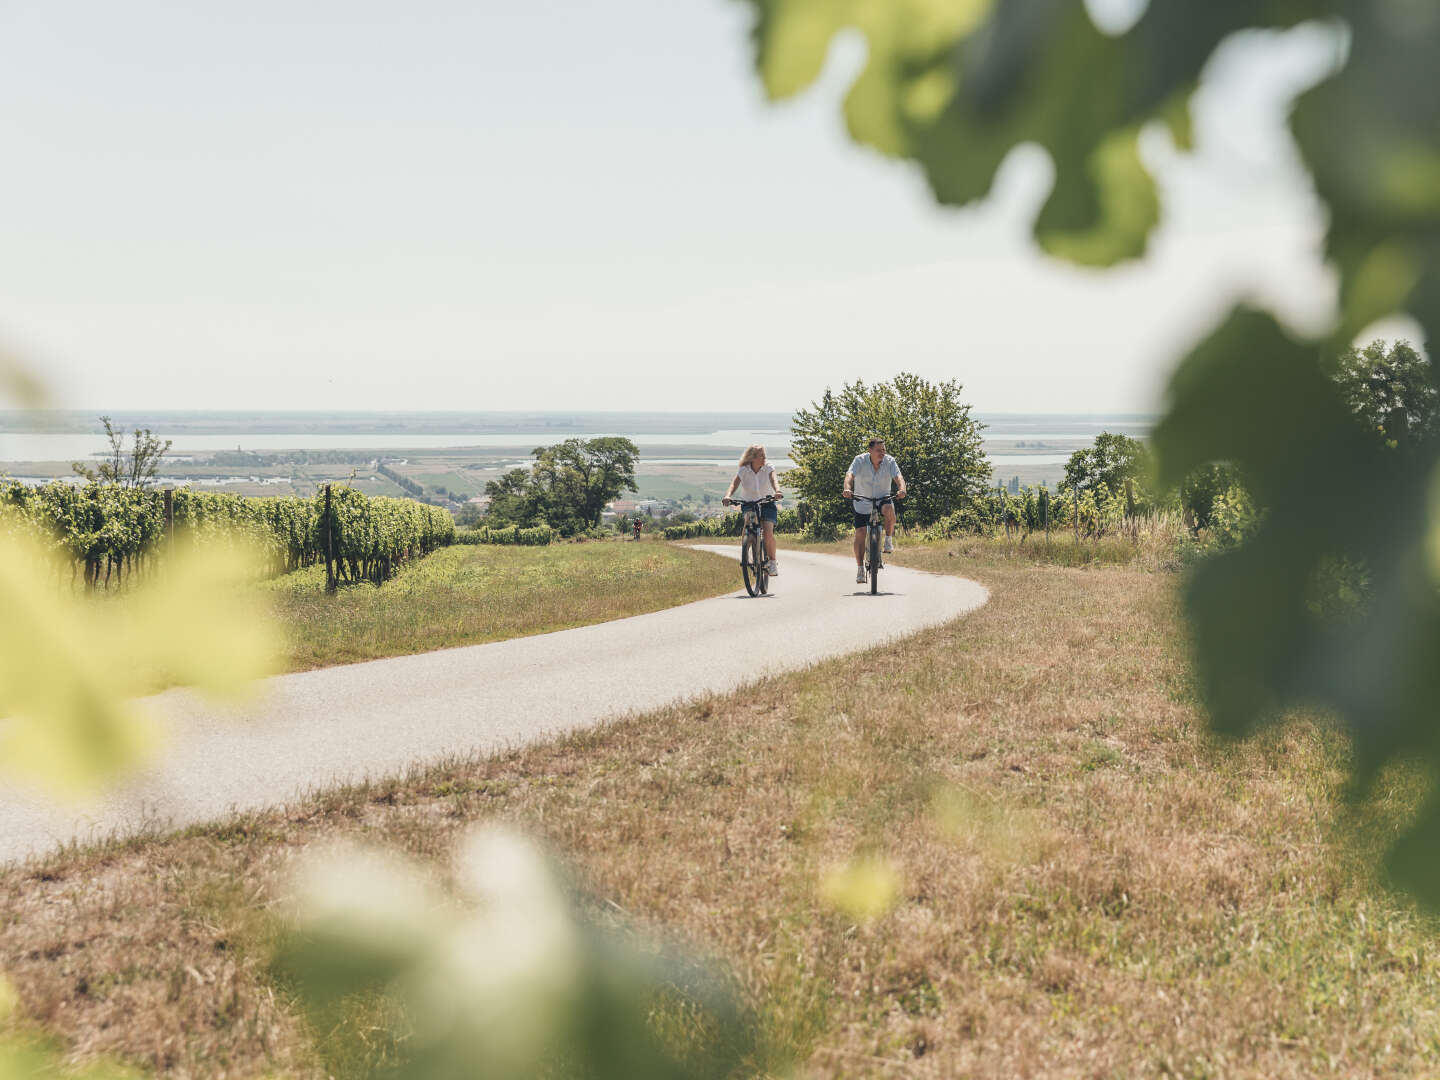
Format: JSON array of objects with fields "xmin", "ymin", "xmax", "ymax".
[{"xmin": 278, "ymin": 828, "xmax": 750, "ymax": 1080}]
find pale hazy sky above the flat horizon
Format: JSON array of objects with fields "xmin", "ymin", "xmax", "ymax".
[{"xmin": 0, "ymin": 0, "xmax": 1365, "ymax": 412}]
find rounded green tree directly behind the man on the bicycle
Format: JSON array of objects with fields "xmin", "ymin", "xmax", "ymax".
[{"xmin": 785, "ymin": 373, "xmax": 991, "ymax": 524}]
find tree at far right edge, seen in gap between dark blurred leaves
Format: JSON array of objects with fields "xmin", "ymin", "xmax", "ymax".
[{"xmin": 1335, "ymin": 340, "xmax": 1440, "ymax": 448}]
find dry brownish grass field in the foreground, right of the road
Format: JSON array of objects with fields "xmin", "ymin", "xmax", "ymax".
[{"xmin": 0, "ymin": 541, "xmax": 1440, "ymax": 1079}]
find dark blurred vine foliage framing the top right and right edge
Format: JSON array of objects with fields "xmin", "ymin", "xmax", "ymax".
[{"xmin": 749, "ymin": 0, "xmax": 1440, "ymax": 904}]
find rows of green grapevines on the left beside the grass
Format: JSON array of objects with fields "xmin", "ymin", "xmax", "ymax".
[{"xmin": 0, "ymin": 481, "xmax": 455, "ymax": 588}]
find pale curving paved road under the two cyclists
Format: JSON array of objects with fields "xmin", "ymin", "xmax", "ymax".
[{"xmin": 0, "ymin": 544, "xmax": 988, "ymax": 861}]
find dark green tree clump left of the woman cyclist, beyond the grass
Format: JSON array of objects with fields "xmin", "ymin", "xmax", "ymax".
[{"xmin": 485, "ymin": 436, "xmax": 639, "ymax": 536}]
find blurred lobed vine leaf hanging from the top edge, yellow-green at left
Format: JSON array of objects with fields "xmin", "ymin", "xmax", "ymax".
[{"xmin": 749, "ymin": 0, "xmax": 1331, "ymax": 265}]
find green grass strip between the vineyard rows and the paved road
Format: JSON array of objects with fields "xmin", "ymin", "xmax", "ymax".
[{"xmin": 262, "ymin": 541, "xmax": 740, "ymax": 671}]
